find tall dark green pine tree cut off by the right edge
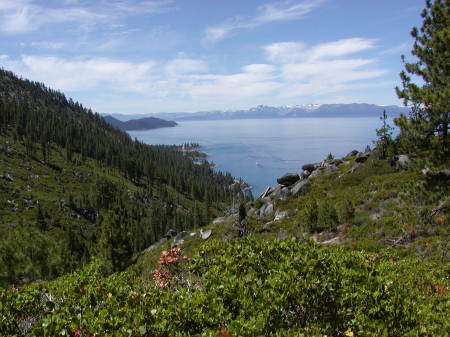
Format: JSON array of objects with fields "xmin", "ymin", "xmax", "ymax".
[{"xmin": 396, "ymin": 0, "xmax": 450, "ymax": 161}]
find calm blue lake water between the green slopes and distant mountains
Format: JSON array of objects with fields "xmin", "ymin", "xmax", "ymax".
[{"xmin": 129, "ymin": 118, "xmax": 381, "ymax": 196}]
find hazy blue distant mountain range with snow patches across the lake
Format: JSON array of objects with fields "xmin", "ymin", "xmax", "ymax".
[{"xmin": 106, "ymin": 103, "xmax": 409, "ymax": 121}]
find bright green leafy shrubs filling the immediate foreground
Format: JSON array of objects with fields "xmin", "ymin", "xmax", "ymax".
[{"xmin": 0, "ymin": 238, "xmax": 450, "ymax": 337}]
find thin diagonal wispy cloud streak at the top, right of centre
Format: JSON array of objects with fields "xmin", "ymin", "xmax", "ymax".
[{"xmin": 204, "ymin": 0, "xmax": 325, "ymax": 43}]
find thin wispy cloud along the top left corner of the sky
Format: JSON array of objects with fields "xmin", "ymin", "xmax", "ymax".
[{"xmin": 0, "ymin": 0, "xmax": 175, "ymax": 34}]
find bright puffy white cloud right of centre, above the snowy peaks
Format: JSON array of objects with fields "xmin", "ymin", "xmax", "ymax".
[{"xmin": 264, "ymin": 38, "xmax": 386, "ymax": 97}]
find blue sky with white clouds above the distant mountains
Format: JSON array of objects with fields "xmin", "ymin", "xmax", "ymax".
[{"xmin": 0, "ymin": 0, "xmax": 424, "ymax": 114}]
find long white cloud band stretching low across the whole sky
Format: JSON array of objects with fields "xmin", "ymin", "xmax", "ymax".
[{"xmin": 0, "ymin": 38, "xmax": 391, "ymax": 112}]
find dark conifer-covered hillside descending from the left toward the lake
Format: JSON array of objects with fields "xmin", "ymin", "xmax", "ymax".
[{"xmin": 0, "ymin": 70, "xmax": 233, "ymax": 285}]
